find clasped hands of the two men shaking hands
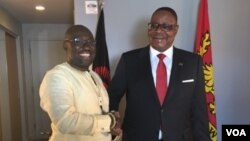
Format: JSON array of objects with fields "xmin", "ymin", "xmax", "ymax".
[{"xmin": 108, "ymin": 111, "xmax": 122, "ymax": 136}]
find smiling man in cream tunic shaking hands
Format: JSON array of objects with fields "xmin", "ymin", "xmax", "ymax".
[{"xmin": 40, "ymin": 25, "xmax": 121, "ymax": 141}]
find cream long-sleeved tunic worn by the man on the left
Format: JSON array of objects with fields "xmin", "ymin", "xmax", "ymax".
[{"xmin": 40, "ymin": 63, "xmax": 111, "ymax": 141}]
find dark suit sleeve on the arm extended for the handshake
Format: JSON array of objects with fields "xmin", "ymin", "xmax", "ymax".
[{"xmin": 108, "ymin": 55, "xmax": 127, "ymax": 111}]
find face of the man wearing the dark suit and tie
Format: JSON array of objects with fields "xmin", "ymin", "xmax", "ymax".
[{"xmin": 148, "ymin": 10, "xmax": 178, "ymax": 52}]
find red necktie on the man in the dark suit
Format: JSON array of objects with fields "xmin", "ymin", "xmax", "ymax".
[{"xmin": 156, "ymin": 54, "xmax": 167, "ymax": 105}]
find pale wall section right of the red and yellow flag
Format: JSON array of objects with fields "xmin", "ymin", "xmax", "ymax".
[{"xmin": 208, "ymin": 0, "xmax": 250, "ymax": 139}]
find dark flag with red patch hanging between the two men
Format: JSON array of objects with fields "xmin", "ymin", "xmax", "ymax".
[{"xmin": 92, "ymin": 9, "xmax": 111, "ymax": 88}]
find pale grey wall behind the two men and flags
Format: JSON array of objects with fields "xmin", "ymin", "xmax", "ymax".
[{"xmin": 75, "ymin": 0, "xmax": 250, "ymax": 141}]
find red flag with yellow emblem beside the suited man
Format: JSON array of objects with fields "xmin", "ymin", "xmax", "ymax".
[{"xmin": 195, "ymin": 0, "xmax": 217, "ymax": 141}]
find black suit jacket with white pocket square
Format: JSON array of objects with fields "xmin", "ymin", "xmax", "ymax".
[{"xmin": 108, "ymin": 46, "xmax": 210, "ymax": 141}]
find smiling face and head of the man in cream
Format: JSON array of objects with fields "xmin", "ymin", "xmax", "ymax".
[{"xmin": 64, "ymin": 25, "xmax": 96, "ymax": 71}]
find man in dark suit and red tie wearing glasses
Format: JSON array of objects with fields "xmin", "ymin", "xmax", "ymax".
[{"xmin": 108, "ymin": 7, "xmax": 210, "ymax": 141}]
